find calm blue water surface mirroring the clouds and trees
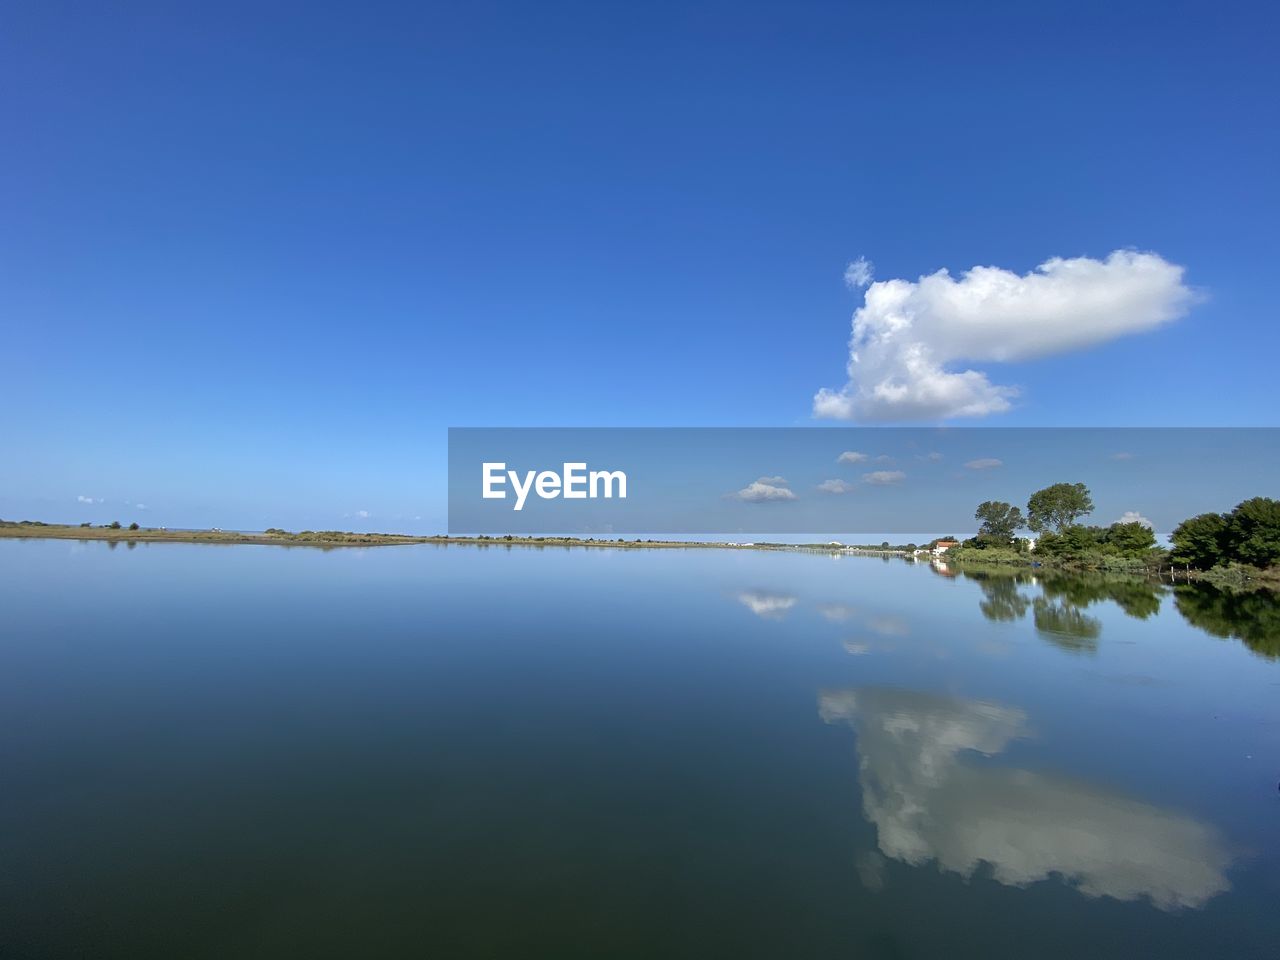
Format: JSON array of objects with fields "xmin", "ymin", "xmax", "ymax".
[{"xmin": 0, "ymin": 541, "xmax": 1280, "ymax": 960}]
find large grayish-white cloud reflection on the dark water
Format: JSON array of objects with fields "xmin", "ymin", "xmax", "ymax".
[{"xmin": 818, "ymin": 689, "xmax": 1231, "ymax": 910}]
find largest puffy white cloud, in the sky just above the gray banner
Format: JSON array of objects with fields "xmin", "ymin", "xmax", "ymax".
[{"xmin": 813, "ymin": 250, "xmax": 1194, "ymax": 421}]
